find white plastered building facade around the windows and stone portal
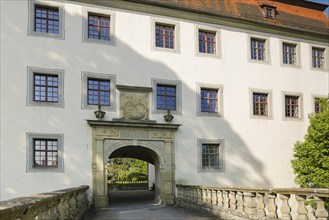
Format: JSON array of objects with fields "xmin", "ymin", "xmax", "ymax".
[{"xmin": 0, "ymin": 1, "xmax": 329, "ymax": 203}]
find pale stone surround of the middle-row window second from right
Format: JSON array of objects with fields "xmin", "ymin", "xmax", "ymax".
[{"xmin": 281, "ymin": 91, "xmax": 304, "ymax": 122}]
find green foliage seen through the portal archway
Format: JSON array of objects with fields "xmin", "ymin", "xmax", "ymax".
[{"xmin": 107, "ymin": 158, "xmax": 148, "ymax": 181}]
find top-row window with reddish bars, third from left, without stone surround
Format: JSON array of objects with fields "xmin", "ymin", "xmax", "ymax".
[{"xmin": 155, "ymin": 24, "xmax": 175, "ymax": 49}]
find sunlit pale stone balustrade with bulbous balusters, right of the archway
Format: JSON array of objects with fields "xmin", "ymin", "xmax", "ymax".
[{"xmin": 176, "ymin": 184, "xmax": 329, "ymax": 220}]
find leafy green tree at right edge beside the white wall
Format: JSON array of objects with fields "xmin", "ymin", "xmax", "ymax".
[{"xmin": 291, "ymin": 98, "xmax": 329, "ymax": 188}]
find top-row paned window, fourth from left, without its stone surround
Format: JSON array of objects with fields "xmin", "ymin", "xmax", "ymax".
[{"xmin": 199, "ymin": 30, "xmax": 216, "ymax": 54}]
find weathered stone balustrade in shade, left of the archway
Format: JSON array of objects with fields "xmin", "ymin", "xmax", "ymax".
[{"xmin": 0, "ymin": 186, "xmax": 89, "ymax": 220}]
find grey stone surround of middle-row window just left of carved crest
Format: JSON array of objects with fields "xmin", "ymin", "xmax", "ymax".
[{"xmin": 81, "ymin": 71, "xmax": 116, "ymax": 112}]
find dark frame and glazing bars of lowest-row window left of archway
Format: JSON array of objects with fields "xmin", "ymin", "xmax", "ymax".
[{"xmin": 33, "ymin": 138, "xmax": 59, "ymax": 168}]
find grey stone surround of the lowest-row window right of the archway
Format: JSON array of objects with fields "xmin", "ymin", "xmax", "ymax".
[{"xmin": 197, "ymin": 138, "xmax": 225, "ymax": 173}]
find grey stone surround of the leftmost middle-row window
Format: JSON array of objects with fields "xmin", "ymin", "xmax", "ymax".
[{"xmin": 26, "ymin": 66, "xmax": 64, "ymax": 108}]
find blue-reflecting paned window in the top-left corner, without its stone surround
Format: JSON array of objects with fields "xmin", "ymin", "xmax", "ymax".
[{"xmin": 34, "ymin": 5, "xmax": 59, "ymax": 34}]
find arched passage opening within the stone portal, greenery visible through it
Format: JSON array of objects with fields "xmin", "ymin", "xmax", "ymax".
[{"xmin": 106, "ymin": 146, "xmax": 161, "ymax": 206}]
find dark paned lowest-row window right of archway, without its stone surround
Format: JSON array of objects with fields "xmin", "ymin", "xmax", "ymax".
[{"xmin": 202, "ymin": 144, "xmax": 220, "ymax": 169}]
